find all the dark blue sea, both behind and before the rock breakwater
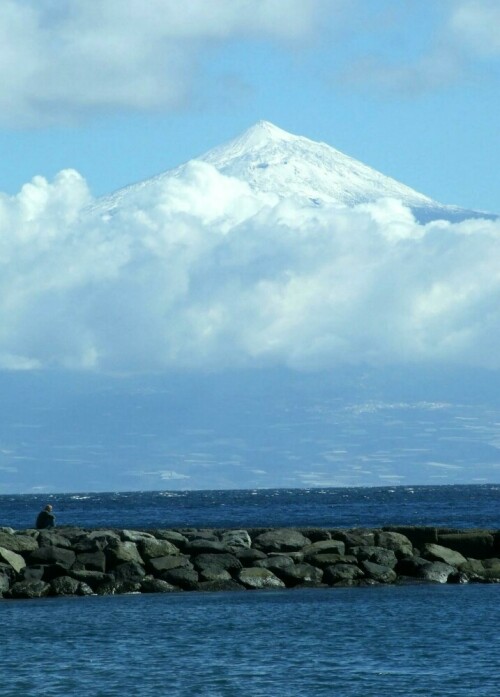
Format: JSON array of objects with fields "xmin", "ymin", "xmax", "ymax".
[{"xmin": 0, "ymin": 485, "xmax": 500, "ymax": 697}]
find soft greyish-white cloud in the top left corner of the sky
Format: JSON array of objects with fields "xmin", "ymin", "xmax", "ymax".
[{"xmin": 0, "ymin": 0, "xmax": 336, "ymax": 127}]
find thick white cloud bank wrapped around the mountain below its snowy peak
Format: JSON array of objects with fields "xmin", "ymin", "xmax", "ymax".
[{"xmin": 0, "ymin": 161, "xmax": 500, "ymax": 372}]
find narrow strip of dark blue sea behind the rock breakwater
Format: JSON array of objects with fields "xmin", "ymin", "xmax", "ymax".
[{"xmin": 0, "ymin": 484, "xmax": 500, "ymax": 529}]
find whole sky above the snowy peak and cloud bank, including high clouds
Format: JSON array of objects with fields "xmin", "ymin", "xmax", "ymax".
[{"xmin": 0, "ymin": 0, "xmax": 500, "ymax": 211}]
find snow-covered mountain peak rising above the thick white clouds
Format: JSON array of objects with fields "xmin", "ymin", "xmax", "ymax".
[{"xmin": 92, "ymin": 121, "xmax": 496, "ymax": 222}]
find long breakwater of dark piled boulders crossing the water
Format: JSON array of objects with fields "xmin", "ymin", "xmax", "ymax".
[{"xmin": 0, "ymin": 526, "xmax": 500, "ymax": 599}]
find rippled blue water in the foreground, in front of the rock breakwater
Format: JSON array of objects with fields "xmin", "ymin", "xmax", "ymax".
[{"xmin": 0, "ymin": 585, "xmax": 500, "ymax": 697}]
